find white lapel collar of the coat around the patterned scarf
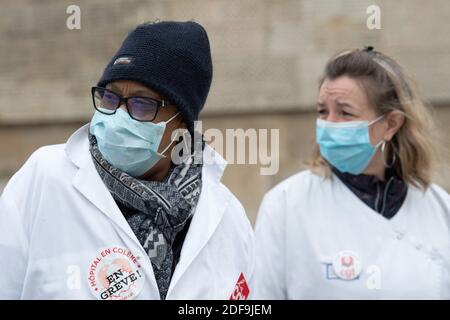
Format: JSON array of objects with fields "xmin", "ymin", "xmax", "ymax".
[{"xmin": 65, "ymin": 124, "xmax": 231, "ymax": 299}]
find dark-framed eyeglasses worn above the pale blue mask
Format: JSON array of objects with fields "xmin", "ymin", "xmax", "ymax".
[{"xmin": 91, "ymin": 87, "xmax": 170, "ymax": 122}]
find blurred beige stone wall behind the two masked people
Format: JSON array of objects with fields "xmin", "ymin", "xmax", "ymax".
[{"xmin": 0, "ymin": 0, "xmax": 450, "ymax": 222}]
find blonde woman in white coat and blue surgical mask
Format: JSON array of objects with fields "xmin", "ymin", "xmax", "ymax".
[{"xmin": 253, "ymin": 47, "xmax": 450, "ymax": 299}]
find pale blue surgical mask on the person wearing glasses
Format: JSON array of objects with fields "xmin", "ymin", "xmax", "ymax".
[{"xmin": 90, "ymin": 108, "xmax": 178, "ymax": 177}]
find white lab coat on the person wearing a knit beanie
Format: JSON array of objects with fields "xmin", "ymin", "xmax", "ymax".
[{"xmin": 0, "ymin": 125, "xmax": 254, "ymax": 299}]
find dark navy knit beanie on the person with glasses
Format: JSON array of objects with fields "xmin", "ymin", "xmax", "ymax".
[{"xmin": 97, "ymin": 21, "xmax": 212, "ymax": 132}]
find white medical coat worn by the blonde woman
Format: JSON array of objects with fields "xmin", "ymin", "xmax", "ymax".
[{"xmin": 254, "ymin": 171, "xmax": 450, "ymax": 299}]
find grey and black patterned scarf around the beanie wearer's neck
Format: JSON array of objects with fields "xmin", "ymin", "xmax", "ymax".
[{"xmin": 89, "ymin": 133, "xmax": 202, "ymax": 300}]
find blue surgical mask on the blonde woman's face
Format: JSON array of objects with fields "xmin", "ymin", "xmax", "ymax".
[{"xmin": 316, "ymin": 116, "xmax": 384, "ymax": 174}]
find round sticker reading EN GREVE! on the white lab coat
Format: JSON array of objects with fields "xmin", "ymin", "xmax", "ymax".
[{"xmin": 88, "ymin": 247, "xmax": 145, "ymax": 300}]
